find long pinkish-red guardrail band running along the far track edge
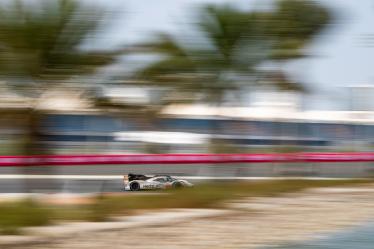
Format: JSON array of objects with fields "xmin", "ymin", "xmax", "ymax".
[{"xmin": 0, "ymin": 152, "xmax": 374, "ymax": 167}]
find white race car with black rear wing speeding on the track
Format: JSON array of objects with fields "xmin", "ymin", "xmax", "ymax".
[{"xmin": 123, "ymin": 174, "xmax": 193, "ymax": 191}]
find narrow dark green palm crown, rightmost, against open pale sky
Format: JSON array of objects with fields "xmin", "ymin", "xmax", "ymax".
[{"xmin": 265, "ymin": 0, "xmax": 332, "ymax": 92}]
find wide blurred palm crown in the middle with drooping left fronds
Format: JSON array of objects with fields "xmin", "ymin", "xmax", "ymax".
[{"xmin": 137, "ymin": 5, "xmax": 268, "ymax": 105}]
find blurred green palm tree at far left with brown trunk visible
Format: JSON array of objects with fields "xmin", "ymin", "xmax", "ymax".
[{"xmin": 0, "ymin": 0, "xmax": 115, "ymax": 154}]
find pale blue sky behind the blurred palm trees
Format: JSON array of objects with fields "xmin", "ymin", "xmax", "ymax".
[{"xmin": 86, "ymin": 0, "xmax": 374, "ymax": 110}]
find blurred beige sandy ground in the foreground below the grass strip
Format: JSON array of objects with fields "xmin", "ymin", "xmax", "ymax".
[{"xmin": 5, "ymin": 184, "xmax": 374, "ymax": 249}]
